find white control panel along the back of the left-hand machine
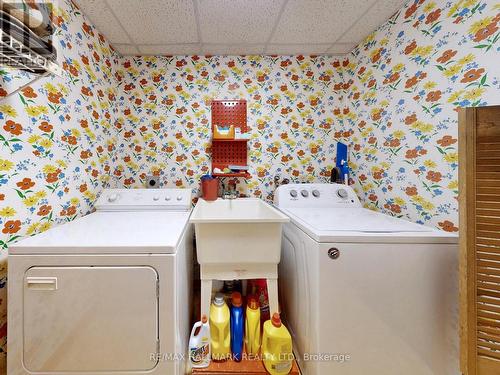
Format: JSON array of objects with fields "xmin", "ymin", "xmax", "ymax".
[{"xmin": 96, "ymin": 189, "xmax": 192, "ymax": 211}]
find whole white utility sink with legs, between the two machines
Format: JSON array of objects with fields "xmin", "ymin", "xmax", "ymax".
[{"xmin": 190, "ymin": 198, "xmax": 290, "ymax": 315}]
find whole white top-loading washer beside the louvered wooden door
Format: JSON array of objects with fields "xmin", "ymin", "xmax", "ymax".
[{"xmin": 275, "ymin": 184, "xmax": 460, "ymax": 375}]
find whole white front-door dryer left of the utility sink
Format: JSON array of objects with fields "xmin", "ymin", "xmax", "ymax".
[{"xmin": 7, "ymin": 189, "xmax": 193, "ymax": 375}]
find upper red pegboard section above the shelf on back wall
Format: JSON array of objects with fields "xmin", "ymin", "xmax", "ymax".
[{"xmin": 212, "ymin": 100, "xmax": 248, "ymax": 133}]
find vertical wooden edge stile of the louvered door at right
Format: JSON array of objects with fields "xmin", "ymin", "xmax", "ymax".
[{"xmin": 458, "ymin": 108, "xmax": 477, "ymax": 375}]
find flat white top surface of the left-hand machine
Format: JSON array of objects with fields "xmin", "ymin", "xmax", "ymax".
[{"xmin": 9, "ymin": 211, "xmax": 190, "ymax": 254}]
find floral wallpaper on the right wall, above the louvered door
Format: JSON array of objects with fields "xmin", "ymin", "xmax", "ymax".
[{"xmin": 343, "ymin": 0, "xmax": 500, "ymax": 231}]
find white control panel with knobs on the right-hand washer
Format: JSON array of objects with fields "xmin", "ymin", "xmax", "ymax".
[{"xmin": 274, "ymin": 183, "xmax": 361, "ymax": 208}]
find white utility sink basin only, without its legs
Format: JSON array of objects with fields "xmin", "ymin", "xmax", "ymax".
[{"xmin": 190, "ymin": 198, "xmax": 290, "ymax": 268}]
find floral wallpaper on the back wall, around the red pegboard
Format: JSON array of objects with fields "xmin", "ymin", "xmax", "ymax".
[{"xmin": 114, "ymin": 56, "xmax": 343, "ymax": 199}]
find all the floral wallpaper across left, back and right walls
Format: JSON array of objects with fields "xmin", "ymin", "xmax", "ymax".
[{"xmin": 0, "ymin": 0, "xmax": 500, "ymax": 371}]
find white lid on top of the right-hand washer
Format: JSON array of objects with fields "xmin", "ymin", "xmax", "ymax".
[{"xmin": 285, "ymin": 208, "xmax": 434, "ymax": 233}]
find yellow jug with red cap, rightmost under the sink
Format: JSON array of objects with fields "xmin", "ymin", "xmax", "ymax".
[{"xmin": 262, "ymin": 313, "xmax": 293, "ymax": 375}]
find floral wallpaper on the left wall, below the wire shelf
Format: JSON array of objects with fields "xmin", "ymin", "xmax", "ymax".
[{"xmin": 0, "ymin": 0, "xmax": 119, "ymax": 369}]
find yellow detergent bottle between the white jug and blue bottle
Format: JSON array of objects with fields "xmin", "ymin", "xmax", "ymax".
[{"xmin": 210, "ymin": 293, "xmax": 231, "ymax": 360}]
